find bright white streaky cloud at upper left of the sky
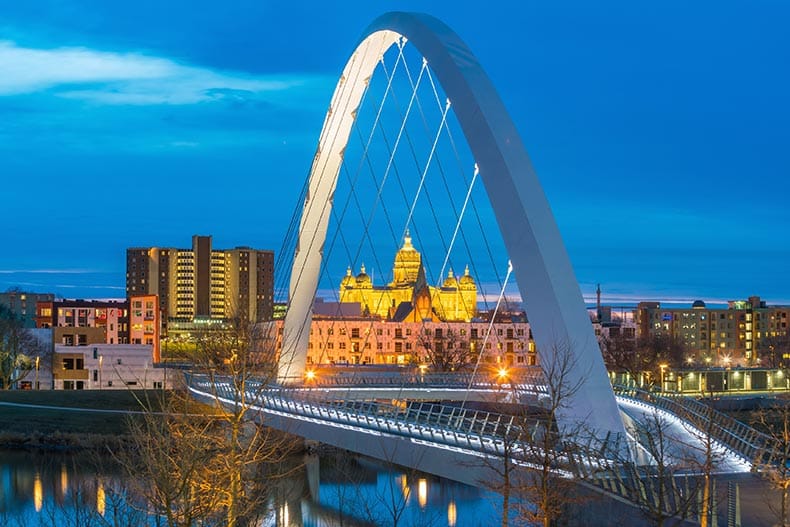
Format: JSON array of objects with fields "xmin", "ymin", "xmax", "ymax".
[{"xmin": 0, "ymin": 41, "xmax": 323, "ymax": 105}]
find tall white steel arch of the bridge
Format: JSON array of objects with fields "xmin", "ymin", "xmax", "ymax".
[{"xmin": 278, "ymin": 12, "xmax": 625, "ymax": 439}]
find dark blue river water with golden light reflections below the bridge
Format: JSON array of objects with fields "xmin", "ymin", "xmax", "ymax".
[{"xmin": 0, "ymin": 451, "xmax": 501, "ymax": 527}]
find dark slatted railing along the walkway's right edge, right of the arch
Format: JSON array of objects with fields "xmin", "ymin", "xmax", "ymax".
[{"xmin": 614, "ymin": 386, "xmax": 784, "ymax": 464}]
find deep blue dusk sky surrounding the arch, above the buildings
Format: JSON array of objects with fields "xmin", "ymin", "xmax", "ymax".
[{"xmin": 0, "ymin": 0, "xmax": 790, "ymax": 303}]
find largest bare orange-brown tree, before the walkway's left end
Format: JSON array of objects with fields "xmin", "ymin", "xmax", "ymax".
[{"xmin": 124, "ymin": 320, "xmax": 293, "ymax": 527}]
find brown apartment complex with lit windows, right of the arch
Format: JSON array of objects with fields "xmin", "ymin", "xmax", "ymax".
[{"xmin": 636, "ymin": 296, "xmax": 790, "ymax": 366}]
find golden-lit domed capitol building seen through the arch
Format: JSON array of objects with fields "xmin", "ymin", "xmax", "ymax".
[{"xmin": 339, "ymin": 232, "xmax": 477, "ymax": 322}]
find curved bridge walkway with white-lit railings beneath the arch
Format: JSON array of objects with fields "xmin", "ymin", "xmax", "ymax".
[{"xmin": 188, "ymin": 375, "xmax": 773, "ymax": 498}]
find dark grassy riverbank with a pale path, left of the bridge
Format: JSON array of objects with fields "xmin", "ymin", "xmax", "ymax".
[{"xmin": 0, "ymin": 390, "xmax": 204, "ymax": 451}]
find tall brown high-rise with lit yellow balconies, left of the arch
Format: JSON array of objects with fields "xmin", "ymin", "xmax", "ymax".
[{"xmin": 126, "ymin": 235, "xmax": 274, "ymax": 332}]
